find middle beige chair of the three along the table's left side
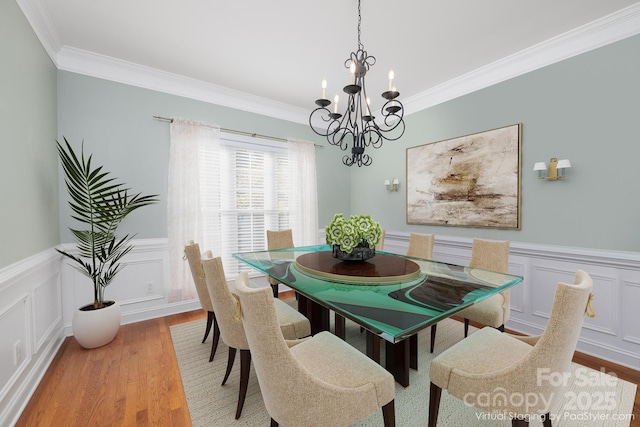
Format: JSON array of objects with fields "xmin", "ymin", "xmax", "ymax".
[{"xmin": 202, "ymin": 251, "xmax": 311, "ymax": 419}]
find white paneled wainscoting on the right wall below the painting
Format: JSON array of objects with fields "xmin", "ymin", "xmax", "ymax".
[{"xmin": 384, "ymin": 231, "xmax": 640, "ymax": 370}]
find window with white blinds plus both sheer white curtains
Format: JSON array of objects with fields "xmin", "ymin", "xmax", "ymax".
[{"xmin": 167, "ymin": 118, "xmax": 318, "ymax": 302}]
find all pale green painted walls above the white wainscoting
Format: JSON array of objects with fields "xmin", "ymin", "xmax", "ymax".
[{"xmin": 6, "ymin": 2, "xmax": 640, "ymax": 258}]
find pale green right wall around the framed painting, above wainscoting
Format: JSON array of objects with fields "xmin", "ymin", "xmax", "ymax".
[{"xmin": 351, "ymin": 36, "xmax": 640, "ymax": 251}]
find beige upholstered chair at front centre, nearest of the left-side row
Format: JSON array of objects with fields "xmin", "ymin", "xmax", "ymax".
[{"xmin": 236, "ymin": 272, "xmax": 395, "ymax": 427}]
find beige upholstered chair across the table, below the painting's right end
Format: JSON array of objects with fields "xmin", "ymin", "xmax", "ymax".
[{"xmin": 431, "ymin": 238, "xmax": 511, "ymax": 353}]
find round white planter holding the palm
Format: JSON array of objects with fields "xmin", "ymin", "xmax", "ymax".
[{"xmin": 71, "ymin": 302, "xmax": 122, "ymax": 348}]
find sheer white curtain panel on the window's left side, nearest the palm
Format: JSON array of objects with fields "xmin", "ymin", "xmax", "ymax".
[{"xmin": 167, "ymin": 119, "xmax": 220, "ymax": 302}]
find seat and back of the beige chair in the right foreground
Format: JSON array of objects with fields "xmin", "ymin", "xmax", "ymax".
[{"xmin": 430, "ymin": 270, "xmax": 593, "ymax": 416}]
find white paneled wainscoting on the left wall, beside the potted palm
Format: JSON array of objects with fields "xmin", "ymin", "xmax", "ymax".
[{"xmin": 0, "ymin": 249, "xmax": 64, "ymax": 426}]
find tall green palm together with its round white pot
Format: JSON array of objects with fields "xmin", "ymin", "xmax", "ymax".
[{"xmin": 56, "ymin": 138, "xmax": 158, "ymax": 348}]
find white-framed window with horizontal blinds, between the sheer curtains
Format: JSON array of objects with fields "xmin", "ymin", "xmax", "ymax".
[{"xmin": 200, "ymin": 133, "xmax": 290, "ymax": 279}]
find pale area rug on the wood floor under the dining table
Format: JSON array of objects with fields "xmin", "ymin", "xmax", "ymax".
[{"xmin": 171, "ymin": 310, "xmax": 636, "ymax": 427}]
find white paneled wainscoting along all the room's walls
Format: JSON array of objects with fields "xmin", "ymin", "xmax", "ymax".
[{"xmin": 0, "ymin": 237, "xmax": 640, "ymax": 425}]
